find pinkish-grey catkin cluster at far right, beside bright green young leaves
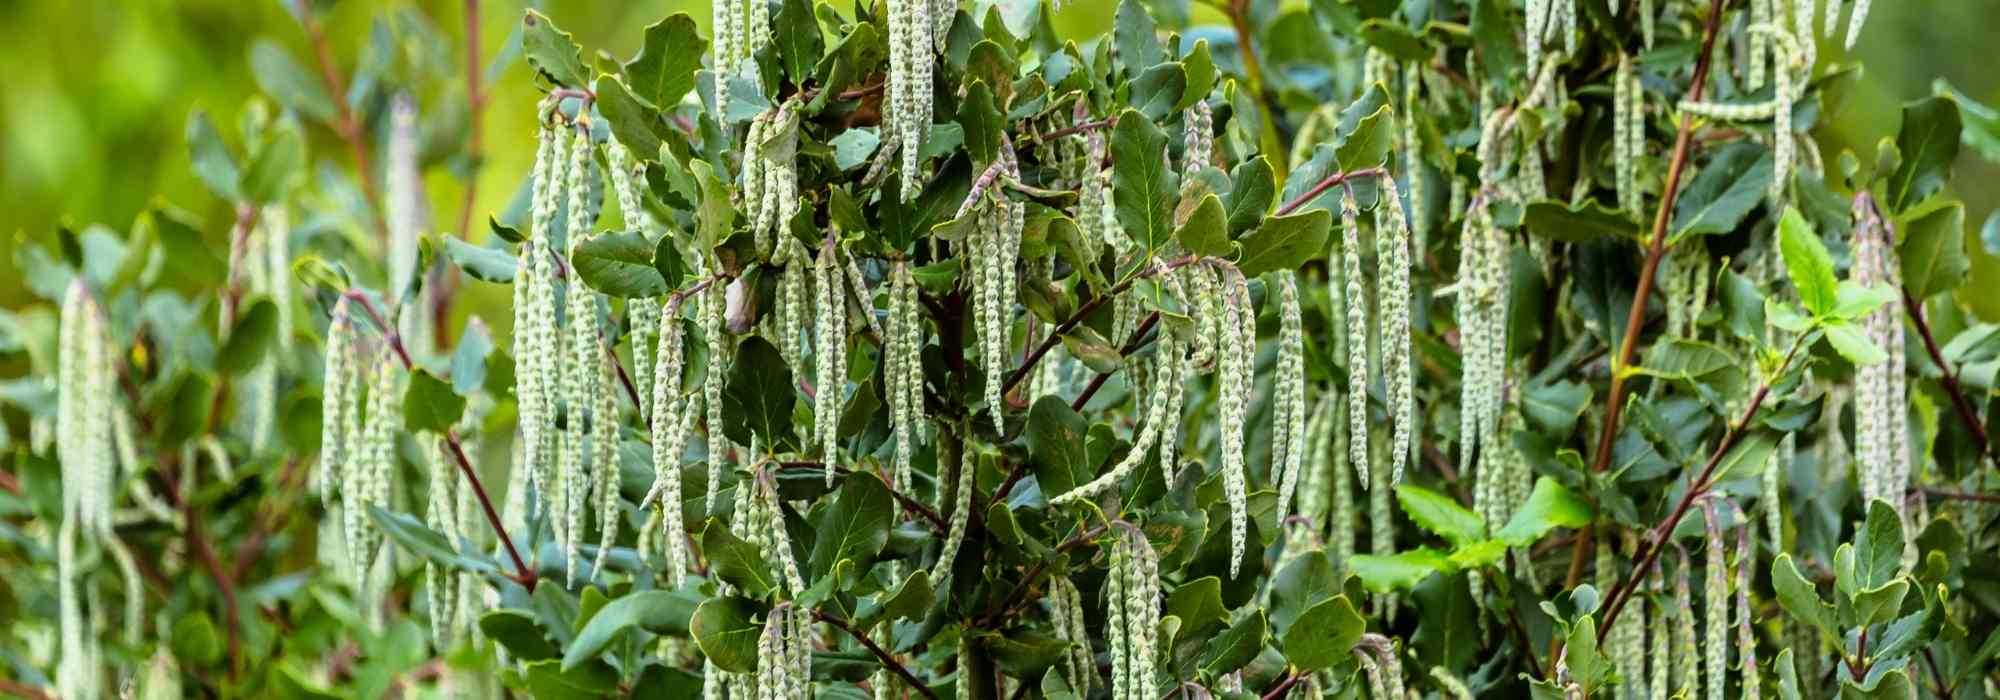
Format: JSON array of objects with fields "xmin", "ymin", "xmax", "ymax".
[{"xmin": 1850, "ymin": 196, "xmax": 1910, "ymax": 514}]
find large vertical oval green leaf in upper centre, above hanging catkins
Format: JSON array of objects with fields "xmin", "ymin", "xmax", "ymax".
[{"xmin": 1112, "ymin": 106, "xmax": 1180, "ymax": 250}]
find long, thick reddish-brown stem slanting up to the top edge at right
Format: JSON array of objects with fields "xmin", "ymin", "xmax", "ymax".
[{"xmin": 1550, "ymin": 0, "xmax": 1722, "ymax": 616}]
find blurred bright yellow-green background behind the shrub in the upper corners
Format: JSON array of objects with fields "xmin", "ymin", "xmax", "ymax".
[{"xmin": 0, "ymin": 0, "xmax": 2000, "ymax": 318}]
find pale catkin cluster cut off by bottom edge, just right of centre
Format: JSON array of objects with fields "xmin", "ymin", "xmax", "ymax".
[{"xmin": 1104, "ymin": 522, "xmax": 1160, "ymax": 700}]
